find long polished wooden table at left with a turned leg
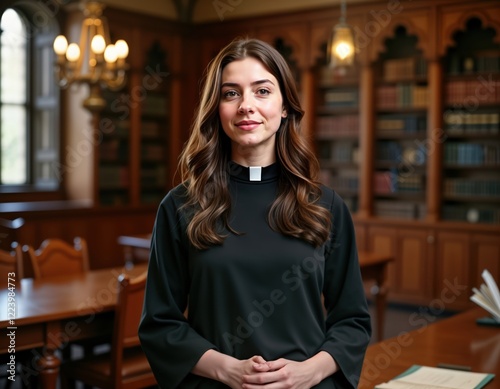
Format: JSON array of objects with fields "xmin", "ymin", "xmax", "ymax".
[{"xmin": 0, "ymin": 264, "xmax": 147, "ymax": 389}]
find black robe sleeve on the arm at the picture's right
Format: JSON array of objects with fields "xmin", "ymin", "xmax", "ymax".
[{"xmin": 321, "ymin": 189, "xmax": 371, "ymax": 388}]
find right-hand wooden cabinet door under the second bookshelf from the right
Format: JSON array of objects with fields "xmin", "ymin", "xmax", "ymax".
[{"xmin": 394, "ymin": 228, "xmax": 433, "ymax": 305}]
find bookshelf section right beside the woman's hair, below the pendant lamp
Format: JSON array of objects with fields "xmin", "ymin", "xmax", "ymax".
[{"xmin": 316, "ymin": 65, "xmax": 360, "ymax": 212}]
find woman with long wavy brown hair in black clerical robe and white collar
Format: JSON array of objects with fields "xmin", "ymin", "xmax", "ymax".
[{"xmin": 139, "ymin": 39, "xmax": 371, "ymax": 389}]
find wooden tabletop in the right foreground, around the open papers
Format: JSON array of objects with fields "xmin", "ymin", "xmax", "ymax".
[{"xmin": 358, "ymin": 308, "xmax": 500, "ymax": 389}]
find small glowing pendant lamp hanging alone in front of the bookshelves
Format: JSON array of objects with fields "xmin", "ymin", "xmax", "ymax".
[{"xmin": 327, "ymin": 0, "xmax": 355, "ymax": 68}]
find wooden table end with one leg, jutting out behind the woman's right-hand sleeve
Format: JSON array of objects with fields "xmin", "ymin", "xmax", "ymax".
[{"xmin": 358, "ymin": 251, "xmax": 394, "ymax": 341}]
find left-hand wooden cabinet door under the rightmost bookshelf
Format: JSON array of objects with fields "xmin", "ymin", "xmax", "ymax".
[{"xmin": 435, "ymin": 232, "xmax": 472, "ymax": 310}]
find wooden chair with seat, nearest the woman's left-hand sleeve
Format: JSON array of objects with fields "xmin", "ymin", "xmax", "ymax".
[{"xmin": 61, "ymin": 272, "xmax": 157, "ymax": 389}]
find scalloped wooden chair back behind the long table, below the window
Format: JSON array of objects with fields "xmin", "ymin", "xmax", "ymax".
[{"xmin": 25, "ymin": 237, "xmax": 89, "ymax": 279}]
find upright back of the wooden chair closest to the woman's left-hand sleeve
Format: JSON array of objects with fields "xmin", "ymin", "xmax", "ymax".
[{"xmin": 111, "ymin": 271, "xmax": 154, "ymax": 383}]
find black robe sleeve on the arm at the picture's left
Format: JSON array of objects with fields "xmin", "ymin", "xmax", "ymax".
[{"xmin": 139, "ymin": 187, "xmax": 215, "ymax": 388}]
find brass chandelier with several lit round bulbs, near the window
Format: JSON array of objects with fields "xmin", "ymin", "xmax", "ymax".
[{"xmin": 54, "ymin": 1, "xmax": 128, "ymax": 112}]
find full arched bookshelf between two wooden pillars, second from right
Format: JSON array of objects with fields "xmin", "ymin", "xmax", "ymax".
[{"xmin": 373, "ymin": 26, "xmax": 428, "ymax": 219}]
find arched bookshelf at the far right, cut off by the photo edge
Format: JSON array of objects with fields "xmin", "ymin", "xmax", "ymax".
[{"xmin": 442, "ymin": 17, "xmax": 500, "ymax": 224}]
